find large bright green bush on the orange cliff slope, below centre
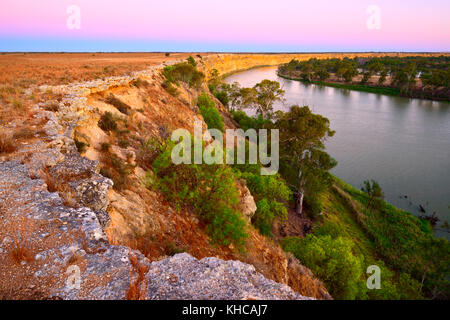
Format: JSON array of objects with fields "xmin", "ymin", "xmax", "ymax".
[{"xmin": 152, "ymin": 139, "xmax": 248, "ymax": 248}]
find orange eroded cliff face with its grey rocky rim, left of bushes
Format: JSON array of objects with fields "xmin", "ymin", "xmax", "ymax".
[{"xmin": 0, "ymin": 53, "xmax": 330, "ymax": 299}]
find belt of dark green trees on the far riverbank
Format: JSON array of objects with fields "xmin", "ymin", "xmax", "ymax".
[{"xmin": 278, "ymin": 56, "xmax": 450, "ymax": 101}]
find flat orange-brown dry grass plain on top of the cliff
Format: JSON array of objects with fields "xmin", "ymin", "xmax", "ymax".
[{"xmin": 0, "ymin": 53, "xmax": 194, "ymax": 124}]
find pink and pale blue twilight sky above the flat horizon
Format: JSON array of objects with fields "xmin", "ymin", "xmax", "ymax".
[{"xmin": 0, "ymin": 0, "xmax": 450, "ymax": 52}]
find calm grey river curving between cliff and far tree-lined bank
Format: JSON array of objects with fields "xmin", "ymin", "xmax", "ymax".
[{"xmin": 225, "ymin": 67, "xmax": 450, "ymax": 238}]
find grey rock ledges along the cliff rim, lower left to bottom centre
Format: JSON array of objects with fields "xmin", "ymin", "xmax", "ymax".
[{"xmin": 0, "ymin": 161, "xmax": 308, "ymax": 299}]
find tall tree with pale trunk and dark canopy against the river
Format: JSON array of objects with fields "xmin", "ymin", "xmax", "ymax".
[{"xmin": 275, "ymin": 106, "xmax": 336, "ymax": 215}]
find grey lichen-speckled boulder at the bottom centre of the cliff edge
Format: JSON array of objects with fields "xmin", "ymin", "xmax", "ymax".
[{"xmin": 147, "ymin": 253, "xmax": 310, "ymax": 300}]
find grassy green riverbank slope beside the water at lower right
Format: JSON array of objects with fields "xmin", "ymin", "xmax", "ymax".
[{"xmin": 326, "ymin": 177, "xmax": 450, "ymax": 299}]
